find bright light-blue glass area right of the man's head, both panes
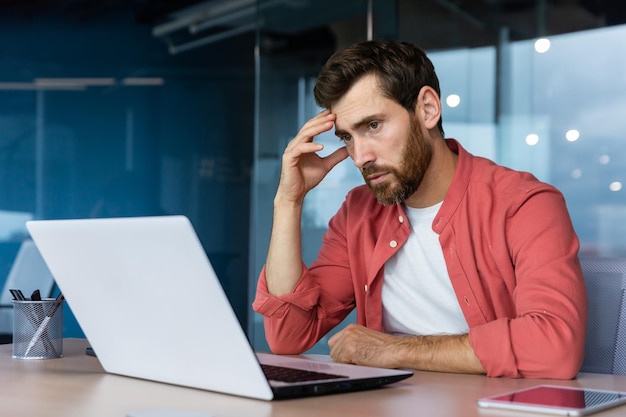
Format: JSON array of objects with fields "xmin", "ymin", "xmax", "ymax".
[{"xmin": 430, "ymin": 26, "xmax": 626, "ymax": 256}]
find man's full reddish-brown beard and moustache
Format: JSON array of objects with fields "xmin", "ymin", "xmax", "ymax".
[{"xmin": 361, "ymin": 117, "xmax": 432, "ymax": 206}]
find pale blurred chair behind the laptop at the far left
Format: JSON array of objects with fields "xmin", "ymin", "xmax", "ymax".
[{"xmin": 0, "ymin": 239, "xmax": 55, "ymax": 343}]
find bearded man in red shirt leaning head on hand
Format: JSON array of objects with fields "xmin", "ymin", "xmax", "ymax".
[{"xmin": 253, "ymin": 41, "xmax": 587, "ymax": 378}]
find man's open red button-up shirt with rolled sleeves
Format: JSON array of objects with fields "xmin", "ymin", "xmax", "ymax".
[{"xmin": 253, "ymin": 140, "xmax": 587, "ymax": 378}]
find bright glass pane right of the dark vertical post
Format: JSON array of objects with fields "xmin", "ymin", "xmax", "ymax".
[{"xmin": 502, "ymin": 25, "xmax": 626, "ymax": 256}]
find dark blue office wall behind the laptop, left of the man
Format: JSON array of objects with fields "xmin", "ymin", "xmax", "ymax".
[{"xmin": 0, "ymin": 11, "xmax": 254, "ymax": 337}]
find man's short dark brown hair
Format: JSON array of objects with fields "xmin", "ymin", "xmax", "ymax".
[{"xmin": 313, "ymin": 41, "xmax": 443, "ymax": 135}]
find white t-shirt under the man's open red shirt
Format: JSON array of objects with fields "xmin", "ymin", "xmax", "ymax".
[{"xmin": 382, "ymin": 203, "xmax": 468, "ymax": 335}]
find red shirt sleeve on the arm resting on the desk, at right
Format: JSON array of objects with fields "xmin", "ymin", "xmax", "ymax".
[{"xmin": 469, "ymin": 187, "xmax": 587, "ymax": 379}]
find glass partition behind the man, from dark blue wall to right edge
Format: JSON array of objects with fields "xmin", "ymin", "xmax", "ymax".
[{"xmin": 250, "ymin": 2, "xmax": 626, "ymax": 353}]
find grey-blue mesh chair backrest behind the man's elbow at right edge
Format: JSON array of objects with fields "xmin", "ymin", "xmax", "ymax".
[{"xmin": 580, "ymin": 257, "xmax": 626, "ymax": 375}]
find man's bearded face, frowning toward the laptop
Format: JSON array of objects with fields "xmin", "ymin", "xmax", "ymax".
[{"xmin": 332, "ymin": 76, "xmax": 432, "ymax": 205}]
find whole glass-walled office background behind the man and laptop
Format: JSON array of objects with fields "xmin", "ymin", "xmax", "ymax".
[{"xmin": 0, "ymin": 0, "xmax": 626, "ymax": 351}]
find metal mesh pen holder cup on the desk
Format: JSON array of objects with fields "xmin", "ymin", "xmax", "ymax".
[{"xmin": 13, "ymin": 298, "xmax": 64, "ymax": 359}]
